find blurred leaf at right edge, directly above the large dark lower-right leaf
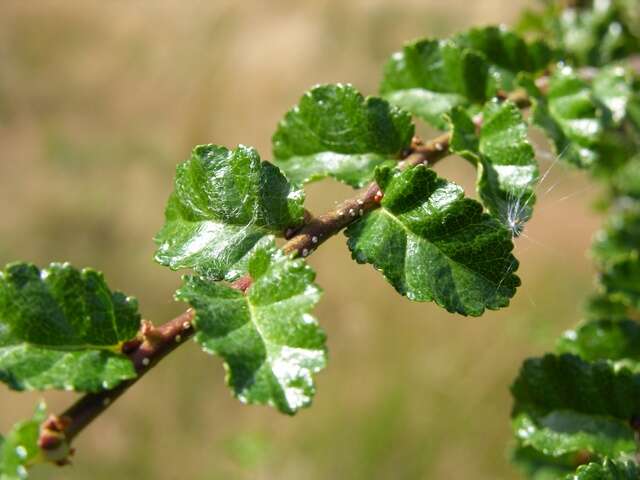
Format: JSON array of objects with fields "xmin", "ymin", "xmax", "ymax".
[{"xmin": 557, "ymin": 320, "xmax": 640, "ymax": 371}]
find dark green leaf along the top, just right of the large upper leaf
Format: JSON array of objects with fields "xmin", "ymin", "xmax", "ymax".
[{"xmin": 455, "ymin": 26, "xmax": 553, "ymax": 90}]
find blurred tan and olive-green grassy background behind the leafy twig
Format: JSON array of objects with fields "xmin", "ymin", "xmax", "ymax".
[{"xmin": 0, "ymin": 0, "xmax": 600, "ymax": 480}]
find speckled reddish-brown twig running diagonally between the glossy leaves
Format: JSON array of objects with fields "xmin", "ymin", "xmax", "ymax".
[{"xmin": 38, "ymin": 57, "xmax": 640, "ymax": 465}]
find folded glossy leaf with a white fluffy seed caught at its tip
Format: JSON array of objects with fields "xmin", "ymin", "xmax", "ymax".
[{"xmin": 450, "ymin": 101, "xmax": 539, "ymax": 231}]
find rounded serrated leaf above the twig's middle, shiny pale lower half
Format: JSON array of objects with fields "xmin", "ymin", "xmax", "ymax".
[{"xmin": 273, "ymin": 84, "xmax": 414, "ymax": 187}]
